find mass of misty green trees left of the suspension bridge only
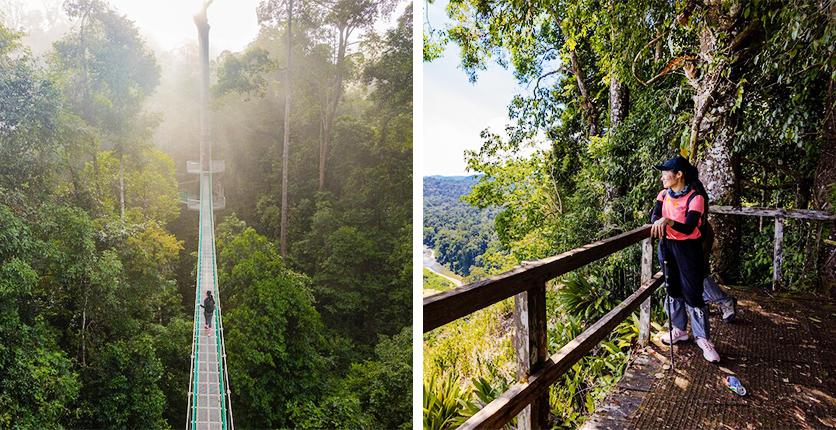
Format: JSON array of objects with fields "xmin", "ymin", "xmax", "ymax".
[{"xmin": 0, "ymin": 9, "xmax": 196, "ymax": 428}]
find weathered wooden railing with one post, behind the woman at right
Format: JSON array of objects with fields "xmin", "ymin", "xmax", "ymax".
[{"xmin": 708, "ymin": 206, "xmax": 836, "ymax": 291}]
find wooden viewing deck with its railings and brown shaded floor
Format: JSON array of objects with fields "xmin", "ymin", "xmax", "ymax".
[{"xmin": 423, "ymin": 207, "xmax": 836, "ymax": 430}]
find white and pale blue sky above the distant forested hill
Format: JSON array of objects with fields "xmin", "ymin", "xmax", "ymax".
[{"xmin": 416, "ymin": 1, "xmax": 523, "ymax": 176}]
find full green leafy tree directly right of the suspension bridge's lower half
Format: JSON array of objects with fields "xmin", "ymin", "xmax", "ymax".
[{"xmin": 218, "ymin": 217, "xmax": 327, "ymax": 427}]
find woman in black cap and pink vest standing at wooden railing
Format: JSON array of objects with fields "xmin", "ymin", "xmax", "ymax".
[{"xmin": 650, "ymin": 157, "xmax": 720, "ymax": 363}]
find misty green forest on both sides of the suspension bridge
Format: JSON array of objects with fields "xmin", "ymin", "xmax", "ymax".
[{"xmin": 0, "ymin": 0, "xmax": 412, "ymax": 428}]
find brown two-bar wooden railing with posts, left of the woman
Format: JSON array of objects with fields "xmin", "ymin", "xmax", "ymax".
[{"xmin": 423, "ymin": 225, "xmax": 662, "ymax": 429}]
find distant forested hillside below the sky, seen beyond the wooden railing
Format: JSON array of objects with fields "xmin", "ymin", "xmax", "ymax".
[{"xmin": 424, "ymin": 176, "xmax": 499, "ymax": 276}]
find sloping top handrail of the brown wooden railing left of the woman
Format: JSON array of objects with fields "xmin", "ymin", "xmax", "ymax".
[{"xmin": 423, "ymin": 225, "xmax": 650, "ymax": 333}]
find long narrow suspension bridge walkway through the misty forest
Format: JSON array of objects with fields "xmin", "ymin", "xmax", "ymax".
[{"xmin": 186, "ymin": 166, "xmax": 234, "ymax": 430}]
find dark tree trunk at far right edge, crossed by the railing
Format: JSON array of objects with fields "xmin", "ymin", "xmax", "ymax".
[{"xmin": 813, "ymin": 80, "xmax": 836, "ymax": 297}]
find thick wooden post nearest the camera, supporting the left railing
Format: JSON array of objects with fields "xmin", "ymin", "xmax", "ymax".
[{"xmin": 514, "ymin": 281, "xmax": 549, "ymax": 430}]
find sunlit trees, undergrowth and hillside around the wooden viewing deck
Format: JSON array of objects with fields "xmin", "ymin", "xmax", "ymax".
[{"xmin": 423, "ymin": 0, "xmax": 836, "ymax": 429}]
